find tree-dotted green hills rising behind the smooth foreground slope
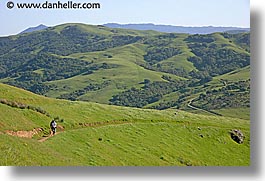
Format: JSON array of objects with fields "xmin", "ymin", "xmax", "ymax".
[{"xmin": 0, "ymin": 23, "xmax": 250, "ymax": 119}]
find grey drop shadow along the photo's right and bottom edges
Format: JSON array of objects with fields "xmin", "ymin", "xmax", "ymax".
[{"xmin": 7, "ymin": 9, "xmax": 263, "ymax": 180}]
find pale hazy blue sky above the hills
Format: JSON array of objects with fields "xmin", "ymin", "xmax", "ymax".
[{"xmin": 0, "ymin": 0, "xmax": 250, "ymax": 36}]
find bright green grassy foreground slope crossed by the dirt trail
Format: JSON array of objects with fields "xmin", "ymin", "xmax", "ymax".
[{"xmin": 0, "ymin": 84, "xmax": 250, "ymax": 166}]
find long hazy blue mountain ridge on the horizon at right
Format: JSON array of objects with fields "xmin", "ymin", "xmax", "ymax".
[{"xmin": 103, "ymin": 23, "xmax": 250, "ymax": 34}]
